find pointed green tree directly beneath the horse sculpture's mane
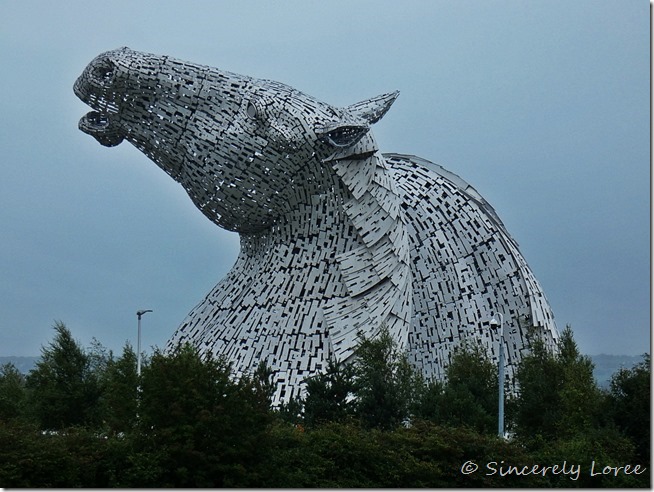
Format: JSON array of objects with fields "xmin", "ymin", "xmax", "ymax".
[{"xmin": 354, "ymin": 327, "xmax": 423, "ymax": 429}]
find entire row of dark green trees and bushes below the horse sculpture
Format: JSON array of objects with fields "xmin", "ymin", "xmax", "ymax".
[{"xmin": 0, "ymin": 323, "xmax": 650, "ymax": 488}]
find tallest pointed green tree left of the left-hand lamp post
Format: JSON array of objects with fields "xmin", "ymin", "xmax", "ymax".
[{"xmin": 26, "ymin": 321, "xmax": 101, "ymax": 429}]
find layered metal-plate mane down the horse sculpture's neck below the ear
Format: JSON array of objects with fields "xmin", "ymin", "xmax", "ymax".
[{"xmin": 324, "ymin": 141, "xmax": 412, "ymax": 361}]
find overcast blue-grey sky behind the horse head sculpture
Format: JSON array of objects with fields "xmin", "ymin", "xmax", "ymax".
[{"xmin": 0, "ymin": 0, "xmax": 650, "ymax": 356}]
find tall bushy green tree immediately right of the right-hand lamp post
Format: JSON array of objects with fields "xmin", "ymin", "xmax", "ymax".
[{"xmin": 510, "ymin": 326, "xmax": 624, "ymax": 476}]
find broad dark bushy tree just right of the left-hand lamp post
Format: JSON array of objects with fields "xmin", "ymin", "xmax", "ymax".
[{"xmin": 134, "ymin": 345, "xmax": 270, "ymax": 487}]
